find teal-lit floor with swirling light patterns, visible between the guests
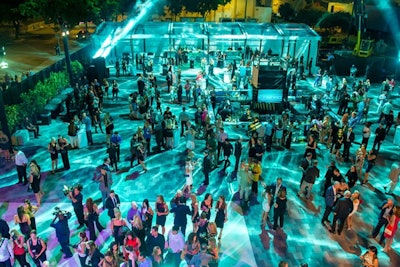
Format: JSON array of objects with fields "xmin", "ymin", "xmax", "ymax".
[{"xmin": 0, "ymin": 63, "xmax": 400, "ymax": 267}]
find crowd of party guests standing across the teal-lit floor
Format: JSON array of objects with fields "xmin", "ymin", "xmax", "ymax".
[{"xmin": 0, "ymin": 46, "xmax": 400, "ymax": 267}]
